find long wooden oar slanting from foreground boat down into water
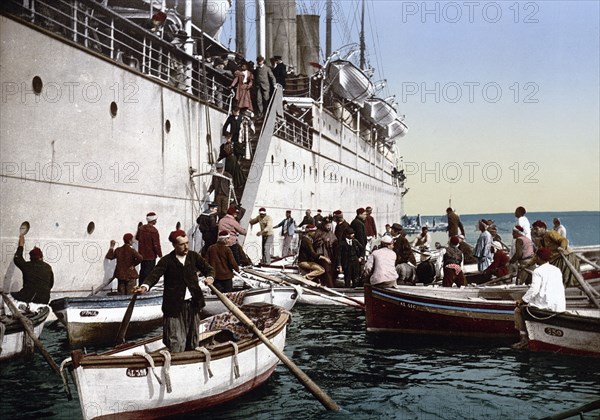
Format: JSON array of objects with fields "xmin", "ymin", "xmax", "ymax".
[{"xmin": 207, "ymin": 284, "xmax": 340, "ymax": 411}]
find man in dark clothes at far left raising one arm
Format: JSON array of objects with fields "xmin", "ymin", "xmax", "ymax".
[{"xmin": 2, "ymin": 234, "xmax": 54, "ymax": 313}]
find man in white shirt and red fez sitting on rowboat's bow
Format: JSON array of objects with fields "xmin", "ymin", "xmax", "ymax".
[{"xmin": 512, "ymin": 248, "xmax": 567, "ymax": 349}]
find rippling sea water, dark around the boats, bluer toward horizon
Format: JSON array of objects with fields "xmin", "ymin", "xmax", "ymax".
[{"xmin": 0, "ymin": 212, "xmax": 600, "ymax": 420}]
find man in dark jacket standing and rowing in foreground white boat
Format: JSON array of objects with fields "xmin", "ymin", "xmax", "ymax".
[{"xmin": 134, "ymin": 230, "xmax": 215, "ymax": 353}]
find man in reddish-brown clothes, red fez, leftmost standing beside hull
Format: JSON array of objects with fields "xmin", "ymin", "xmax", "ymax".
[{"xmin": 106, "ymin": 233, "xmax": 144, "ymax": 295}]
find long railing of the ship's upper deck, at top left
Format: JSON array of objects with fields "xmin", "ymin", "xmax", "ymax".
[{"xmin": 0, "ymin": 0, "xmax": 233, "ymax": 111}]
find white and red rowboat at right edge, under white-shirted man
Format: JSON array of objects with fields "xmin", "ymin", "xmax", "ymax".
[{"xmin": 523, "ymin": 306, "xmax": 600, "ymax": 357}]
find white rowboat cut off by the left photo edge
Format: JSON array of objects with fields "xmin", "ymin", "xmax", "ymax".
[{"xmin": 0, "ymin": 306, "xmax": 50, "ymax": 360}]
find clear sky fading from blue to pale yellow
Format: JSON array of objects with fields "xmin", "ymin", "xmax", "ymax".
[{"xmin": 221, "ymin": 0, "xmax": 600, "ymax": 214}]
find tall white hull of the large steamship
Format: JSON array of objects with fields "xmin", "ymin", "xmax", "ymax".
[{"xmin": 0, "ymin": 10, "xmax": 403, "ymax": 299}]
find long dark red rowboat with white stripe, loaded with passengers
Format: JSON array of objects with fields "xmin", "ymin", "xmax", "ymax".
[{"xmin": 365, "ymin": 285, "xmax": 589, "ymax": 338}]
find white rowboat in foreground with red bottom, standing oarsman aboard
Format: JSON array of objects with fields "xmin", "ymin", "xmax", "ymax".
[{"xmin": 63, "ymin": 304, "xmax": 290, "ymax": 419}]
